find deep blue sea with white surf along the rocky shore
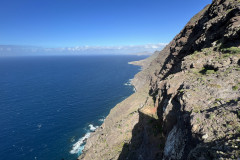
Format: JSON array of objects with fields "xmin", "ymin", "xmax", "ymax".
[{"xmin": 0, "ymin": 56, "xmax": 146, "ymax": 160}]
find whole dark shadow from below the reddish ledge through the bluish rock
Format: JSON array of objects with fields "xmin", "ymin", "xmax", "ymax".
[{"xmin": 118, "ymin": 89, "xmax": 201, "ymax": 160}]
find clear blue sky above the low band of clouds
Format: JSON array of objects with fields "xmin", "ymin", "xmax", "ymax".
[{"xmin": 0, "ymin": 0, "xmax": 211, "ymax": 55}]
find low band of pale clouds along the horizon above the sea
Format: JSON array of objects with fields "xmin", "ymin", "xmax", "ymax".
[{"xmin": 0, "ymin": 43, "xmax": 167, "ymax": 56}]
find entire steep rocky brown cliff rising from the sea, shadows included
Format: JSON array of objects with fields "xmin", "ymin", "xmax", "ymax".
[{"xmin": 79, "ymin": 0, "xmax": 240, "ymax": 160}]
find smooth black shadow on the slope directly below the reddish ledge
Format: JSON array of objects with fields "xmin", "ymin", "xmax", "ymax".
[{"xmin": 118, "ymin": 111, "xmax": 164, "ymax": 160}]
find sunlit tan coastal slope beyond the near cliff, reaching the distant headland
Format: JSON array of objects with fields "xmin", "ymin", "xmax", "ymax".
[{"xmin": 78, "ymin": 45, "xmax": 169, "ymax": 160}]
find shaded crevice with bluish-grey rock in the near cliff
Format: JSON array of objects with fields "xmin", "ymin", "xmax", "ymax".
[{"xmin": 163, "ymin": 94, "xmax": 200, "ymax": 160}]
